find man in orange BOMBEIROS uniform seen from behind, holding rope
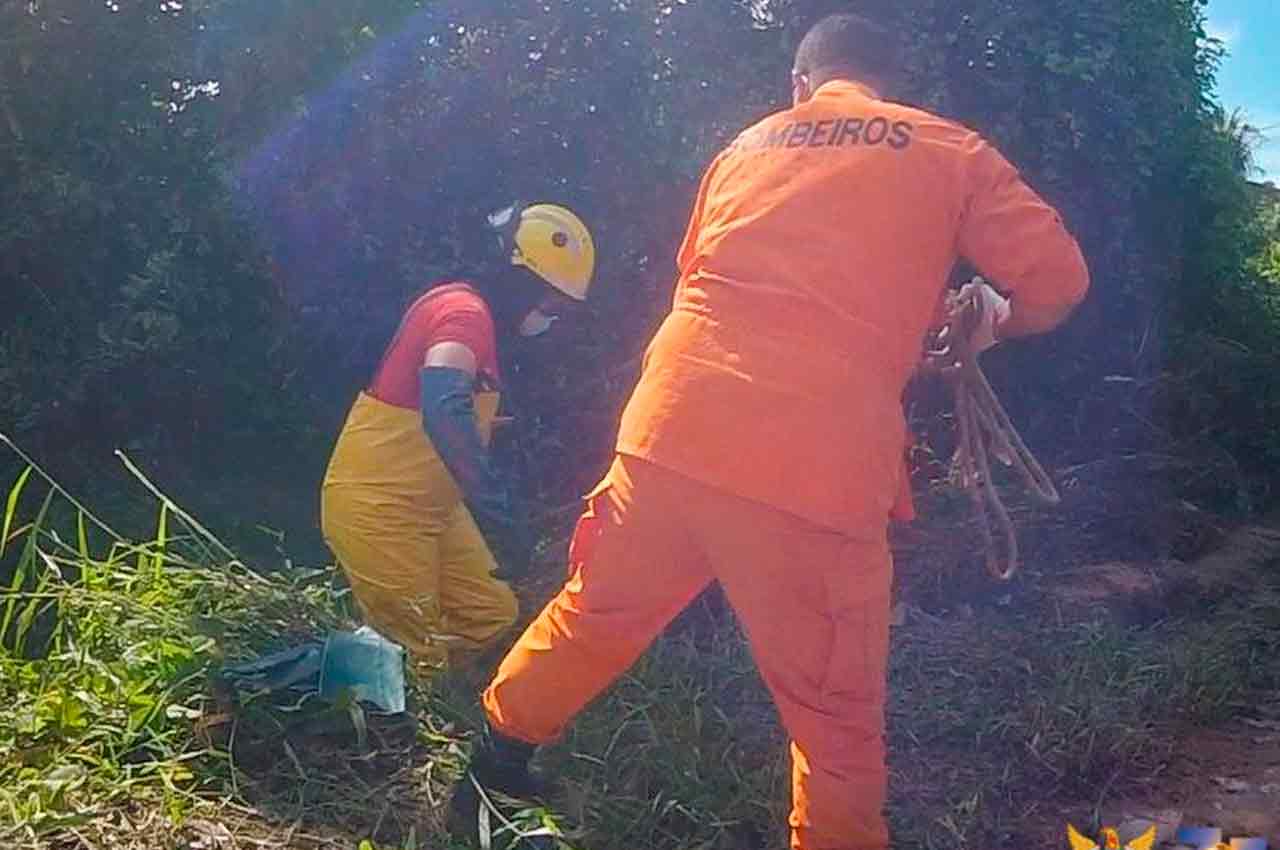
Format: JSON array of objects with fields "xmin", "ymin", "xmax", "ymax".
[{"xmin": 453, "ymin": 14, "xmax": 1088, "ymax": 850}]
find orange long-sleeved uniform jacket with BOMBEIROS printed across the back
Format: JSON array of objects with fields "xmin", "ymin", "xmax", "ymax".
[{"xmin": 617, "ymin": 81, "xmax": 1088, "ymax": 533}]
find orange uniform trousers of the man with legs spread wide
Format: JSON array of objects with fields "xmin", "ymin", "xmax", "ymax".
[{"xmin": 484, "ymin": 454, "xmax": 892, "ymax": 850}]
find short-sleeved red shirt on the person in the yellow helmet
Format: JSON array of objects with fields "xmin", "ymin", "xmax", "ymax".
[{"xmin": 367, "ymin": 283, "xmax": 499, "ymax": 410}]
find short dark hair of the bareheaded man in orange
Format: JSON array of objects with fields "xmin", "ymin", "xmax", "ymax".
[{"xmin": 795, "ymin": 13, "xmax": 902, "ymax": 81}]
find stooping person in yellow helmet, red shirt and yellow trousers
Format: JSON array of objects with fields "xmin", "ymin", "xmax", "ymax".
[{"xmin": 320, "ymin": 204, "xmax": 595, "ymax": 673}]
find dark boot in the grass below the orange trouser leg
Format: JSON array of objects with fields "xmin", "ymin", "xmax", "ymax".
[{"xmin": 449, "ymin": 723, "xmax": 558, "ymax": 850}]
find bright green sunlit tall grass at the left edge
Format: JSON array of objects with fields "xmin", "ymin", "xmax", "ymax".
[{"xmin": 0, "ymin": 440, "xmax": 350, "ymax": 846}]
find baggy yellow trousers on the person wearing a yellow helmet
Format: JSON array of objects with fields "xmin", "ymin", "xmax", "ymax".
[{"xmin": 320, "ymin": 394, "xmax": 517, "ymax": 668}]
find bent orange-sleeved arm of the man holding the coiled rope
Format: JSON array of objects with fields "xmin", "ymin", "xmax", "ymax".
[{"xmin": 959, "ymin": 136, "xmax": 1089, "ymax": 339}]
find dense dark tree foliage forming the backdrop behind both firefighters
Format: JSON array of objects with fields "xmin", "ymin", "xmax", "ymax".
[{"xmin": 0, "ymin": 0, "xmax": 1280, "ymax": 512}]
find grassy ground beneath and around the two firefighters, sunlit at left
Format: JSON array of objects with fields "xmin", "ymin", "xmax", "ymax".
[{"xmin": 0, "ymin": 437, "xmax": 1280, "ymax": 850}]
